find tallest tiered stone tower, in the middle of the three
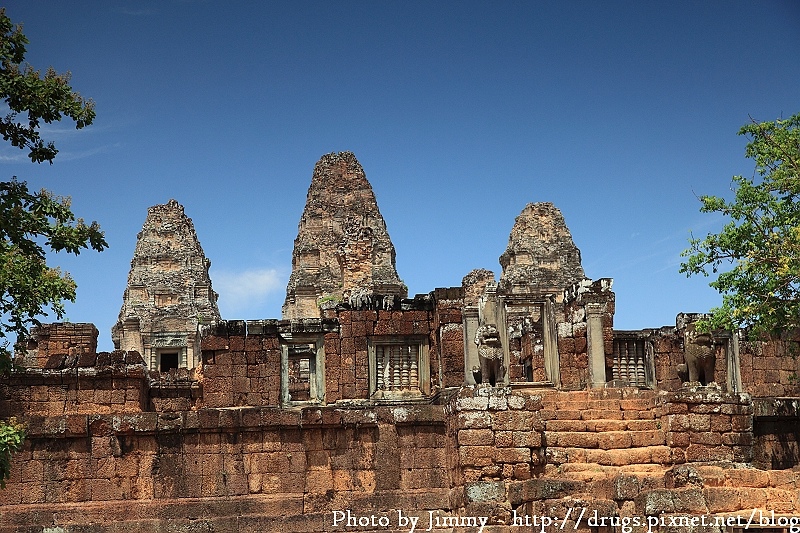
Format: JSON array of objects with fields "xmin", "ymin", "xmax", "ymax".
[{"xmin": 283, "ymin": 152, "xmax": 408, "ymax": 319}]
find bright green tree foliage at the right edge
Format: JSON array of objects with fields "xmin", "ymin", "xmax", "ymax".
[{"xmin": 681, "ymin": 114, "xmax": 800, "ymax": 335}]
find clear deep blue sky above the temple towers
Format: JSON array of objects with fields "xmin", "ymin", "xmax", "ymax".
[{"xmin": 0, "ymin": 0, "xmax": 800, "ymax": 350}]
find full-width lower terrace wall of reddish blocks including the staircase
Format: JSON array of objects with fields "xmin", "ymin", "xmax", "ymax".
[{"xmin": 0, "ymin": 371, "xmax": 800, "ymax": 533}]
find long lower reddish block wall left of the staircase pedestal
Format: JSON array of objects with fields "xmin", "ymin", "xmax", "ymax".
[{"xmin": 0, "ymin": 406, "xmax": 450, "ymax": 532}]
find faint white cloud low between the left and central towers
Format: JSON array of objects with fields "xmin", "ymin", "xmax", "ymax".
[{"xmin": 211, "ymin": 268, "xmax": 286, "ymax": 318}]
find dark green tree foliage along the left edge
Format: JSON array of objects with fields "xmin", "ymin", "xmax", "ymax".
[{"xmin": 0, "ymin": 9, "xmax": 108, "ymax": 486}]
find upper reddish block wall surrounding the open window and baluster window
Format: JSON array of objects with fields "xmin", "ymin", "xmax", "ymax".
[{"xmin": 201, "ymin": 303, "xmax": 456, "ymax": 407}]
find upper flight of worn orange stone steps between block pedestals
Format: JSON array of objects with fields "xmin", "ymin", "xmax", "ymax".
[{"xmin": 540, "ymin": 388, "xmax": 671, "ymax": 481}]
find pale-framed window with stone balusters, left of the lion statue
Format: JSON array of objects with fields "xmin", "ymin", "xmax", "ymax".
[{"xmin": 369, "ymin": 335, "xmax": 430, "ymax": 400}]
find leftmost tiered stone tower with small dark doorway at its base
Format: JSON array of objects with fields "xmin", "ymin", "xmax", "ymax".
[{"xmin": 111, "ymin": 200, "xmax": 220, "ymax": 371}]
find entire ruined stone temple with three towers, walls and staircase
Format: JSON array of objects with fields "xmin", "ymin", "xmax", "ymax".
[{"xmin": 0, "ymin": 152, "xmax": 800, "ymax": 533}]
